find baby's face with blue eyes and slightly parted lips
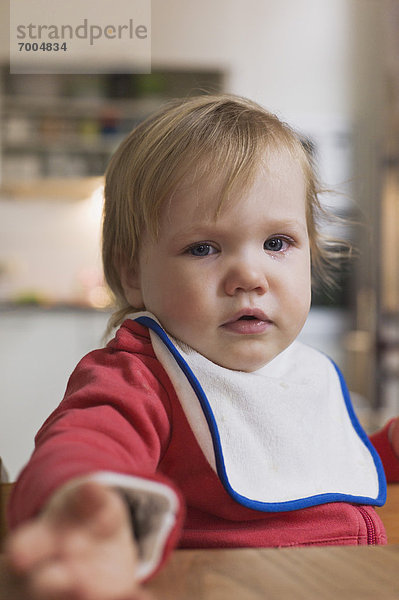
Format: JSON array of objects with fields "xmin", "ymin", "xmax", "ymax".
[{"xmin": 127, "ymin": 154, "xmax": 311, "ymax": 371}]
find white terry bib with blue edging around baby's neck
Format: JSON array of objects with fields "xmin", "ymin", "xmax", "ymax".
[{"xmin": 134, "ymin": 312, "xmax": 386, "ymax": 511}]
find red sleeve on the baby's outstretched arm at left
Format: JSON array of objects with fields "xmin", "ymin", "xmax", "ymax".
[{"xmin": 8, "ymin": 346, "xmax": 182, "ymax": 539}]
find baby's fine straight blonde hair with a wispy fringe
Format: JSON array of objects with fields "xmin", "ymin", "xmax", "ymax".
[{"xmin": 102, "ymin": 94, "xmax": 347, "ymax": 328}]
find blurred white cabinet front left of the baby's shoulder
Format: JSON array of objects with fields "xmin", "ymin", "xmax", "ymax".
[{"xmin": 0, "ymin": 307, "xmax": 110, "ymax": 480}]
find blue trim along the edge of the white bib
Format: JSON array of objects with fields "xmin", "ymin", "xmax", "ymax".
[{"xmin": 134, "ymin": 316, "xmax": 386, "ymax": 512}]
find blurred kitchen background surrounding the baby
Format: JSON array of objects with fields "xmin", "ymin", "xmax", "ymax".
[{"xmin": 0, "ymin": 0, "xmax": 399, "ymax": 479}]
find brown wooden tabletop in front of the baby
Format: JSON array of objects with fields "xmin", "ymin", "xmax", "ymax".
[{"xmin": 146, "ymin": 545, "xmax": 399, "ymax": 600}]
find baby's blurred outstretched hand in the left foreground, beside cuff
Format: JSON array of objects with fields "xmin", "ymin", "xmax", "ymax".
[{"xmin": 0, "ymin": 482, "xmax": 148, "ymax": 600}]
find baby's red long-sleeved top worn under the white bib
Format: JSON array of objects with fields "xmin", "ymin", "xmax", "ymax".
[{"xmin": 9, "ymin": 320, "xmax": 399, "ymax": 568}]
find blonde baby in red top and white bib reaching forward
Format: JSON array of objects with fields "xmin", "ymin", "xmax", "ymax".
[{"xmin": 6, "ymin": 95, "xmax": 399, "ymax": 600}]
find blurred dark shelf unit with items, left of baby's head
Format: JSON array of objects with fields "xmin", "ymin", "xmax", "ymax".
[{"xmin": 0, "ymin": 69, "xmax": 223, "ymax": 184}]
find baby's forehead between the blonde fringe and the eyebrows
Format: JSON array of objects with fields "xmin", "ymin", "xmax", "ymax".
[{"xmin": 161, "ymin": 150, "xmax": 307, "ymax": 227}]
